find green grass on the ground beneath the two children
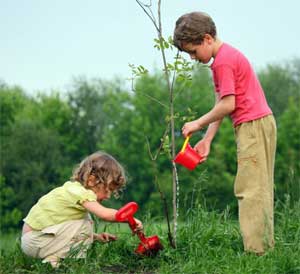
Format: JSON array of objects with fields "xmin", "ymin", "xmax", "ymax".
[{"xmin": 0, "ymin": 199, "xmax": 300, "ymax": 274}]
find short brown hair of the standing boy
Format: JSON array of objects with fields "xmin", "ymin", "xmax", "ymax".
[{"xmin": 173, "ymin": 12, "xmax": 217, "ymax": 50}]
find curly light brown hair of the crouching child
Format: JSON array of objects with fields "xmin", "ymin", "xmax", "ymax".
[{"xmin": 71, "ymin": 151, "xmax": 126, "ymax": 198}]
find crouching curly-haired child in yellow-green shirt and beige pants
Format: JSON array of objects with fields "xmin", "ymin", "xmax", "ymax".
[{"xmin": 21, "ymin": 152, "xmax": 142, "ymax": 267}]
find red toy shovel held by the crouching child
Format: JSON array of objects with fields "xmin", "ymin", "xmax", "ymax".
[{"xmin": 115, "ymin": 202, "xmax": 163, "ymax": 256}]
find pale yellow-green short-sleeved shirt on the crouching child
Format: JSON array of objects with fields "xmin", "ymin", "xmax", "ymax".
[{"xmin": 23, "ymin": 182, "xmax": 97, "ymax": 230}]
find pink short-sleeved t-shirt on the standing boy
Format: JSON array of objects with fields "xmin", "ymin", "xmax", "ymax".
[{"xmin": 211, "ymin": 43, "xmax": 272, "ymax": 126}]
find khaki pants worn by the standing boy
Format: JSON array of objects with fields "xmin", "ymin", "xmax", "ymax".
[{"xmin": 234, "ymin": 115, "xmax": 276, "ymax": 253}]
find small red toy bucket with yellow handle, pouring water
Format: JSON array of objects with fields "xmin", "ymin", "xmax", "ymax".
[{"xmin": 174, "ymin": 136, "xmax": 202, "ymax": 170}]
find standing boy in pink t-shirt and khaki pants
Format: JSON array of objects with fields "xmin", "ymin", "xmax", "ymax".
[{"xmin": 173, "ymin": 12, "xmax": 276, "ymax": 254}]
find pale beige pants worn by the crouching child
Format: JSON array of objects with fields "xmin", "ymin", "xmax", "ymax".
[{"xmin": 21, "ymin": 218, "xmax": 93, "ymax": 262}]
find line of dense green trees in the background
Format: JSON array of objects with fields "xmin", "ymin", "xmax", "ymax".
[{"xmin": 0, "ymin": 59, "xmax": 300, "ymax": 231}]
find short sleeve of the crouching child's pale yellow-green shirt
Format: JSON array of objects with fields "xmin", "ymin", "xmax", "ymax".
[{"xmin": 66, "ymin": 182, "xmax": 97, "ymax": 205}]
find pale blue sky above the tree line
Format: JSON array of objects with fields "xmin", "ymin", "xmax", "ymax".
[{"xmin": 0, "ymin": 0, "xmax": 300, "ymax": 94}]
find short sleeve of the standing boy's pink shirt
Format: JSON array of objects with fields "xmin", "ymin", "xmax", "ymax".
[{"xmin": 213, "ymin": 65, "xmax": 235, "ymax": 98}]
